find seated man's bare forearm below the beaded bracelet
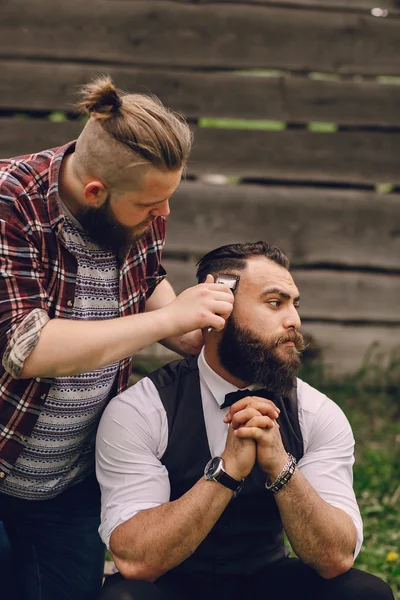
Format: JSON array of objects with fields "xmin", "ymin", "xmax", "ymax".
[{"xmin": 276, "ymin": 469, "xmax": 357, "ymax": 579}]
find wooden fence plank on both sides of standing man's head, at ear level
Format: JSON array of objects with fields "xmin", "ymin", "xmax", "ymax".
[{"xmin": 0, "ymin": 118, "xmax": 400, "ymax": 184}]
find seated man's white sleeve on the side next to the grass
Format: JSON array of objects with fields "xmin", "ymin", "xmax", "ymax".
[{"xmin": 298, "ymin": 382, "xmax": 363, "ymax": 556}]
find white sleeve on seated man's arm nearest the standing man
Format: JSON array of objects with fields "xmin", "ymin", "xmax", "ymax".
[{"xmin": 96, "ymin": 378, "xmax": 170, "ymax": 547}]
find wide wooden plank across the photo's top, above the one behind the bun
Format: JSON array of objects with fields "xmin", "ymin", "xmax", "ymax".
[{"xmin": 0, "ymin": 0, "xmax": 400, "ymax": 75}]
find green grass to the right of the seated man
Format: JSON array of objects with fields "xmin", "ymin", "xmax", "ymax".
[{"xmin": 302, "ymin": 361, "xmax": 400, "ymax": 600}]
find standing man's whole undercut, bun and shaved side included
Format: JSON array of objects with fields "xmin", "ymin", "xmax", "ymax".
[{"xmin": 75, "ymin": 76, "xmax": 193, "ymax": 187}]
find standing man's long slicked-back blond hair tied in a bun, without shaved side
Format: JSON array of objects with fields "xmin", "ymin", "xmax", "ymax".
[{"xmin": 77, "ymin": 75, "xmax": 193, "ymax": 171}]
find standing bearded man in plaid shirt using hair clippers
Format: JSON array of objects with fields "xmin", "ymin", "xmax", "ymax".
[{"xmin": 0, "ymin": 77, "xmax": 233, "ymax": 600}]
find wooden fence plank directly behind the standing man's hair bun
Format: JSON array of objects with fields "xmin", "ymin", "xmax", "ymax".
[{"xmin": 0, "ymin": 59, "xmax": 400, "ymax": 126}]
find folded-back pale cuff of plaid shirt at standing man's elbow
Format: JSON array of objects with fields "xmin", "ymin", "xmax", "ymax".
[{"xmin": 3, "ymin": 308, "xmax": 50, "ymax": 379}]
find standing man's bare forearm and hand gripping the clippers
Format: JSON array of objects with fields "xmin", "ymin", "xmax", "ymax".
[{"xmin": 20, "ymin": 279, "xmax": 233, "ymax": 378}]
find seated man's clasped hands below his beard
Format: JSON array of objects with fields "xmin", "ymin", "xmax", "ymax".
[{"xmin": 222, "ymin": 396, "xmax": 288, "ymax": 480}]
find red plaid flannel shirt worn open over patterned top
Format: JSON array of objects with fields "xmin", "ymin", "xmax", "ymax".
[{"xmin": 0, "ymin": 142, "xmax": 166, "ymax": 483}]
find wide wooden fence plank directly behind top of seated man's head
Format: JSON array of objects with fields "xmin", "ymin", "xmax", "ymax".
[{"xmin": 166, "ymin": 182, "xmax": 400, "ymax": 270}]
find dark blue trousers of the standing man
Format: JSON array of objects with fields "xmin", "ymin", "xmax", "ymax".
[{"xmin": 0, "ymin": 476, "xmax": 104, "ymax": 600}]
